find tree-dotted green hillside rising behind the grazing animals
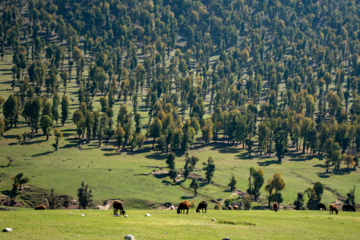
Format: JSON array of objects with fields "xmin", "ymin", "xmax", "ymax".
[{"xmin": 0, "ymin": 0, "xmax": 360, "ymax": 208}]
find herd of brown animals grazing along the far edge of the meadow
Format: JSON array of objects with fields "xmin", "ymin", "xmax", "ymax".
[{"xmin": 34, "ymin": 200, "xmax": 356, "ymax": 215}]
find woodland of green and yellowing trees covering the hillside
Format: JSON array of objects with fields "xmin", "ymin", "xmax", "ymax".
[{"xmin": 0, "ymin": 0, "xmax": 360, "ymax": 208}]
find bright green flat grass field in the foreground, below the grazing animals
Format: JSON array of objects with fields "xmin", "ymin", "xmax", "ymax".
[{"xmin": 0, "ymin": 209, "xmax": 360, "ymax": 240}]
